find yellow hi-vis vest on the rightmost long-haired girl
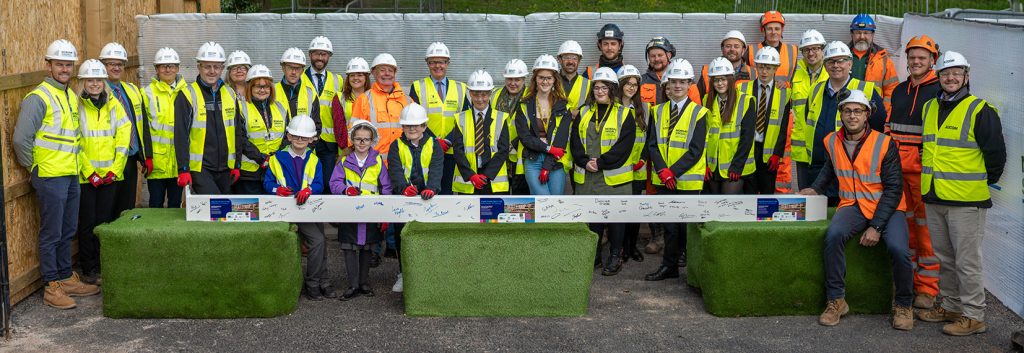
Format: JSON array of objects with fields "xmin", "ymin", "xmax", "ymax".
[{"xmin": 705, "ymin": 92, "xmax": 757, "ymax": 178}]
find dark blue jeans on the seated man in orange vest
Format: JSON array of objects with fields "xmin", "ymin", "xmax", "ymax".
[{"xmin": 824, "ymin": 206, "xmax": 913, "ymax": 307}]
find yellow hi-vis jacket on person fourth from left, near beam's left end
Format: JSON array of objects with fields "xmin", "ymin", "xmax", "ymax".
[{"xmin": 139, "ymin": 76, "xmax": 186, "ymax": 179}]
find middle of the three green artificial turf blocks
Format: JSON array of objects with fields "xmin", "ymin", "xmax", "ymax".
[{"xmin": 401, "ymin": 222, "xmax": 597, "ymax": 316}]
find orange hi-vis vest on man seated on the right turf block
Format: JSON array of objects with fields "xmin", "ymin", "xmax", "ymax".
[{"xmin": 825, "ymin": 129, "xmax": 906, "ymax": 219}]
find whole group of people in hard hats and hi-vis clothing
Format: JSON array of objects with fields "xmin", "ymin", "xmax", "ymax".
[{"xmin": 13, "ymin": 11, "xmax": 1006, "ymax": 336}]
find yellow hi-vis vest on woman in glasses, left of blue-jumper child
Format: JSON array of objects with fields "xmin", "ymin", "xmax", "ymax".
[{"xmin": 240, "ymin": 101, "xmax": 288, "ymax": 172}]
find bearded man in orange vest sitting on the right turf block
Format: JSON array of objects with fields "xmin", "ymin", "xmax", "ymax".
[{"xmin": 799, "ymin": 90, "xmax": 913, "ymax": 330}]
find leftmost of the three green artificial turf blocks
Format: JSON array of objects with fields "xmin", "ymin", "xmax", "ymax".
[{"xmin": 96, "ymin": 209, "xmax": 302, "ymax": 318}]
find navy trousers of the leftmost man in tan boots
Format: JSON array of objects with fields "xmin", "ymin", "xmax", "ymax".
[{"xmin": 32, "ymin": 171, "xmax": 82, "ymax": 282}]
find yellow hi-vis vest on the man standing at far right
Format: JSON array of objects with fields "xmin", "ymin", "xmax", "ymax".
[{"xmin": 921, "ymin": 95, "xmax": 994, "ymax": 203}]
